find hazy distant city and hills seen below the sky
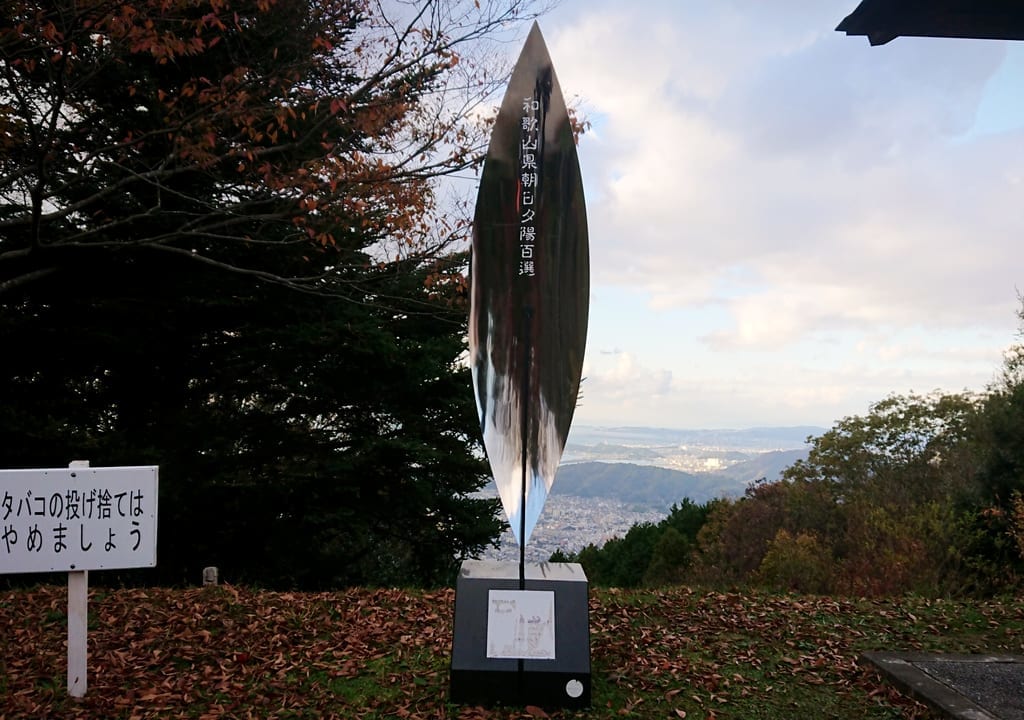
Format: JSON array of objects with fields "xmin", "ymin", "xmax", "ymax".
[{"xmin": 482, "ymin": 426, "xmax": 825, "ymax": 562}]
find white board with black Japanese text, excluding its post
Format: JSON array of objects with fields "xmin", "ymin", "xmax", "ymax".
[{"xmin": 0, "ymin": 465, "xmax": 158, "ymax": 574}]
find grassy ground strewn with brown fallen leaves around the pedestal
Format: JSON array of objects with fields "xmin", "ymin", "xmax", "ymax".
[{"xmin": 0, "ymin": 586, "xmax": 1024, "ymax": 720}]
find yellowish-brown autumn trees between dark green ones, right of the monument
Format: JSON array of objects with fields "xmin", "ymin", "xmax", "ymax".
[{"xmin": 695, "ymin": 395, "xmax": 1024, "ymax": 597}]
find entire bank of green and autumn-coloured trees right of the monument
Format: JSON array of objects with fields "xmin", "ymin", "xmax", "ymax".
[{"xmin": 573, "ymin": 303, "xmax": 1024, "ymax": 597}]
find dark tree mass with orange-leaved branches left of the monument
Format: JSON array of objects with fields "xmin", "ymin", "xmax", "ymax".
[{"xmin": 0, "ymin": 0, "xmax": 548, "ymax": 587}]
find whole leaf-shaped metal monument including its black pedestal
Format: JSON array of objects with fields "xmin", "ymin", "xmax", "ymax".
[{"xmin": 451, "ymin": 24, "xmax": 591, "ymax": 709}]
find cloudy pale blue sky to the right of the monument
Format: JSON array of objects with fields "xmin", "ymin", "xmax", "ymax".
[{"xmin": 493, "ymin": 0, "xmax": 1024, "ymax": 428}]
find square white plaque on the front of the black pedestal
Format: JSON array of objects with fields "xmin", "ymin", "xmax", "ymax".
[{"xmin": 487, "ymin": 590, "xmax": 555, "ymax": 660}]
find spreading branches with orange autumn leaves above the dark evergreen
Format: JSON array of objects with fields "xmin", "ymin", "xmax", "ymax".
[{"xmin": 0, "ymin": 0, "xmax": 522, "ymax": 292}]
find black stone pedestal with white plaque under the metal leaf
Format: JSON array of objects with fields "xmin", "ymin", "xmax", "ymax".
[{"xmin": 451, "ymin": 560, "xmax": 591, "ymax": 709}]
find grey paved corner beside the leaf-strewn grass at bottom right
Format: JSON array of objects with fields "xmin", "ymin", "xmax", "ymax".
[{"xmin": 862, "ymin": 652, "xmax": 1024, "ymax": 720}]
